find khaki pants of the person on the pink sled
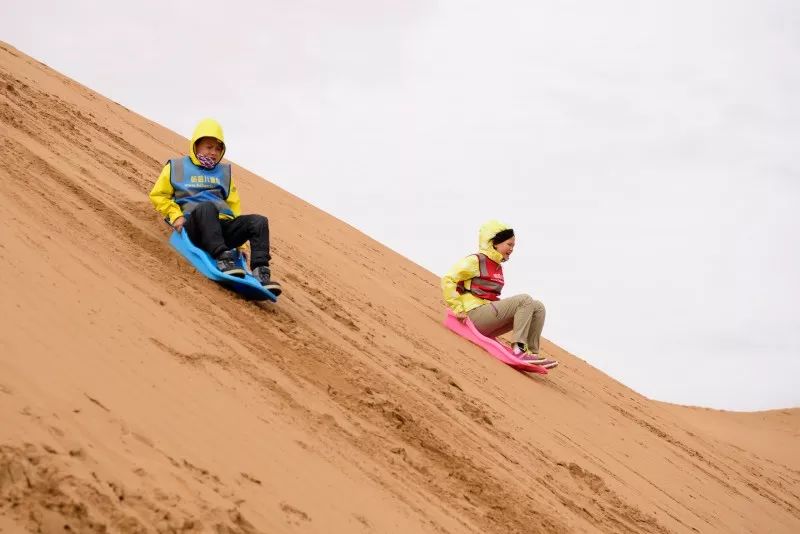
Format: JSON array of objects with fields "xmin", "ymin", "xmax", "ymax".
[{"xmin": 467, "ymin": 295, "xmax": 545, "ymax": 354}]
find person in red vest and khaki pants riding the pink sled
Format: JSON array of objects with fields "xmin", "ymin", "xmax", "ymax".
[{"xmin": 441, "ymin": 220, "xmax": 558, "ymax": 368}]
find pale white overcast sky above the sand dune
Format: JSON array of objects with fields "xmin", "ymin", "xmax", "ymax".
[{"xmin": 0, "ymin": 0, "xmax": 800, "ymax": 410}]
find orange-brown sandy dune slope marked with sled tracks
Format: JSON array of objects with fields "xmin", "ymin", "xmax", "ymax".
[{"xmin": 0, "ymin": 45, "xmax": 800, "ymax": 533}]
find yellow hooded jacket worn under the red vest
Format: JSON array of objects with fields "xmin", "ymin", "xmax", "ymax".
[{"xmin": 441, "ymin": 220, "xmax": 508, "ymax": 313}]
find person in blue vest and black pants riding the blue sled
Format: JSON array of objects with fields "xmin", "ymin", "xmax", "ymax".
[{"xmin": 150, "ymin": 119, "xmax": 281, "ymax": 295}]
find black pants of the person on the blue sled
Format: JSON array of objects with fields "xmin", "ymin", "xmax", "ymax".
[{"xmin": 183, "ymin": 202, "xmax": 270, "ymax": 269}]
